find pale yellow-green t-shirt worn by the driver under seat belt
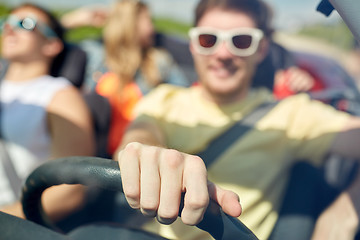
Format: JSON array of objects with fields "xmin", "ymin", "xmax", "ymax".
[{"xmin": 131, "ymin": 85, "xmax": 349, "ymax": 240}]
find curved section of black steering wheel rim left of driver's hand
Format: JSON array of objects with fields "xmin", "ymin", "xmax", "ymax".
[{"xmin": 21, "ymin": 157, "xmax": 122, "ymax": 230}]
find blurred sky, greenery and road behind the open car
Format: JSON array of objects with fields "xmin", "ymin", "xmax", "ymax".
[{"xmin": 0, "ymin": 0, "xmax": 360, "ymax": 86}]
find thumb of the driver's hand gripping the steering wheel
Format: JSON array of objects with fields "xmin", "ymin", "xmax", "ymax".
[{"xmin": 208, "ymin": 181, "xmax": 242, "ymax": 217}]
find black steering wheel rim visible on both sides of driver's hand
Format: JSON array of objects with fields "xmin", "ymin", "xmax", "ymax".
[{"xmin": 21, "ymin": 157, "xmax": 257, "ymax": 240}]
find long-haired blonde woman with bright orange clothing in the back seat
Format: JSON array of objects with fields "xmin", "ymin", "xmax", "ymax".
[{"xmin": 96, "ymin": 0, "xmax": 190, "ymax": 154}]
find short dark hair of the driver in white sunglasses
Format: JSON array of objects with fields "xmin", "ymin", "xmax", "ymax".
[{"xmin": 195, "ymin": 0, "xmax": 273, "ymax": 37}]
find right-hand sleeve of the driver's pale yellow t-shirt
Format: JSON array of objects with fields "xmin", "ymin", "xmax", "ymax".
[{"xmin": 283, "ymin": 94, "xmax": 350, "ymax": 164}]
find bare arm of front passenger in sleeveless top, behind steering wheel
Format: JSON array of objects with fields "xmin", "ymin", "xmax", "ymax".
[{"xmin": 42, "ymin": 87, "xmax": 95, "ymax": 220}]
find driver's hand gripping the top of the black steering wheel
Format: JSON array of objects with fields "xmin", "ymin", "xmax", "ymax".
[{"xmin": 117, "ymin": 143, "xmax": 241, "ymax": 225}]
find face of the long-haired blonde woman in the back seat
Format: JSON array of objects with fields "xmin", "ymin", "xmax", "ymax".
[{"xmin": 137, "ymin": 9, "xmax": 155, "ymax": 48}]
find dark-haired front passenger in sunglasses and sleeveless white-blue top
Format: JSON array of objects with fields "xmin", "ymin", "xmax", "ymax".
[{"xmin": 0, "ymin": 4, "xmax": 94, "ymax": 220}]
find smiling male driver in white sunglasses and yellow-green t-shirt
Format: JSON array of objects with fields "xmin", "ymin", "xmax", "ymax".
[{"xmin": 116, "ymin": 0, "xmax": 360, "ymax": 239}]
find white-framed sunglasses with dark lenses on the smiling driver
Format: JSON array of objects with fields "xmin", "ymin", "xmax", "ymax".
[{"xmin": 189, "ymin": 27, "xmax": 264, "ymax": 57}]
